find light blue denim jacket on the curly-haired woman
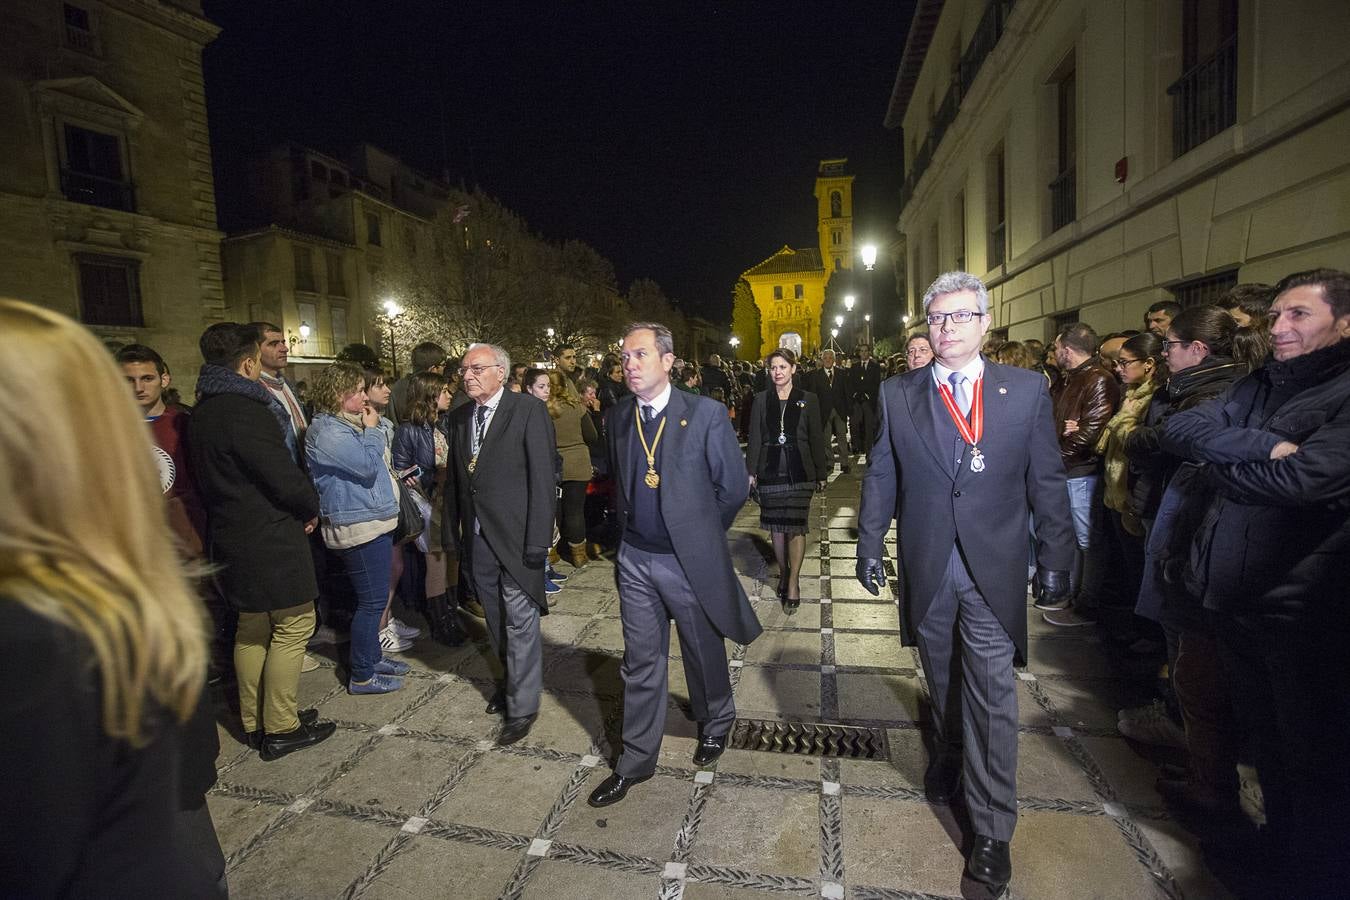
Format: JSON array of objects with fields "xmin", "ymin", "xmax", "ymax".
[{"xmin": 305, "ymin": 413, "xmax": 398, "ymax": 525}]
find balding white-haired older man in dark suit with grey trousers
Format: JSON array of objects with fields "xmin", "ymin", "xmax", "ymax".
[{"xmin": 444, "ymin": 344, "xmax": 558, "ymax": 746}]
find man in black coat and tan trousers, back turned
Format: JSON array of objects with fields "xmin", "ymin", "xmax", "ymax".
[{"xmin": 188, "ymin": 322, "xmax": 336, "ymax": 760}]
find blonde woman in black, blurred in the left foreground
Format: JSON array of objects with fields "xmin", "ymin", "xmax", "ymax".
[{"xmin": 0, "ymin": 300, "xmax": 224, "ymax": 897}]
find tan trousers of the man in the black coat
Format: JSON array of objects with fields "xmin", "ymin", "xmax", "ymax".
[{"xmin": 235, "ymin": 600, "xmax": 315, "ymax": 734}]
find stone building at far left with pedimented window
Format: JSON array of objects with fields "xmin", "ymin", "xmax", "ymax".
[{"xmin": 0, "ymin": 0, "xmax": 224, "ymax": 388}]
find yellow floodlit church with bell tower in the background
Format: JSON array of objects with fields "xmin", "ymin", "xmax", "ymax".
[{"xmin": 741, "ymin": 159, "xmax": 853, "ymax": 358}]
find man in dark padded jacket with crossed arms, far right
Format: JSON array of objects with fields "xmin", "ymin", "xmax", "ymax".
[{"xmin": 1162, "ymin": 269, "xmax": 1350, "ymax": 897}]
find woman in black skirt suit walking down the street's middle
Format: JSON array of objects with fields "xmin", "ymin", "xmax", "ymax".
[{"xmin": 745, "ymin": 348, "xmax": 830, "ymax": 611}]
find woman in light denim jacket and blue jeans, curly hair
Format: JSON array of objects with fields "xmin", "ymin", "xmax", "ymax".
[{"xmin": 305, "ymin": 363, "xmax": 409, "ymax": 694}]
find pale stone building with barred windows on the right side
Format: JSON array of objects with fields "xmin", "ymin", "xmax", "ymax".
[{"xmin": 886, "ymin": 0, "xmax": 1350, "ymax": 339}]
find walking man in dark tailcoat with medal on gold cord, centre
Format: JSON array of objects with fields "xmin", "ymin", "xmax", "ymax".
[{"xmin": 587, "ymin": 322, "xmax": 761, "ymax": 807}]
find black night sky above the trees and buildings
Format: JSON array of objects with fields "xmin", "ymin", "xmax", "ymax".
[{"xmin": 205, "ymin": 0, "xmax": 913, "ymax": 321}]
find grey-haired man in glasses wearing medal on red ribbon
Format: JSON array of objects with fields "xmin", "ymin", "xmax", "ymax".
[{"xmin": 857, "ymin": 273, "xmax": 1073, "ymax": 885}]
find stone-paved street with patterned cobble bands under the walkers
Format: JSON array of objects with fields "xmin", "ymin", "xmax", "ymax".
[{"xmin": 209, "ymin": 475, "xmax": 1227, "ymax": 900}]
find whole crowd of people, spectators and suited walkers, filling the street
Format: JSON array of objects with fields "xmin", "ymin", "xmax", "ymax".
[{"xmin": 0, "ymin": 269, "xmax": 1350, "ymax": 896}]
